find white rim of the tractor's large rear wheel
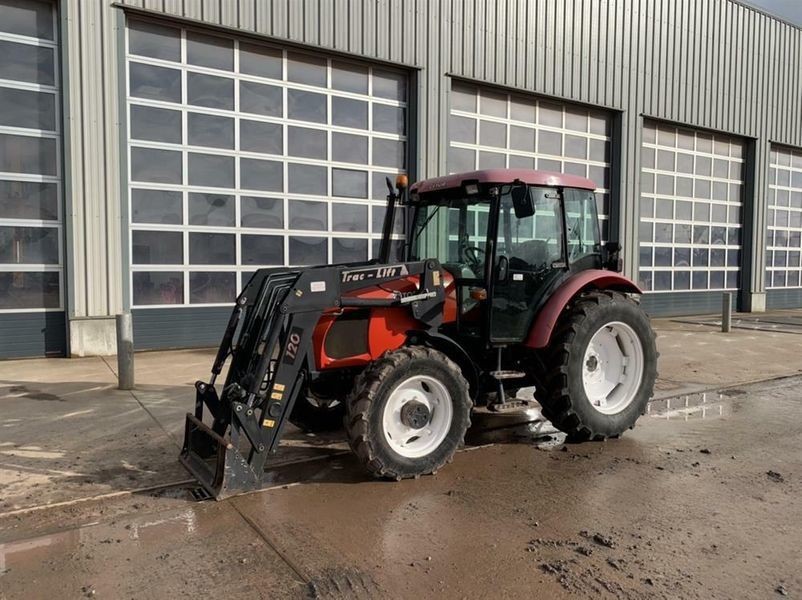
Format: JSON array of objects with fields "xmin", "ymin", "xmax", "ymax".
[{"xmin": 582, "ymin": 321, "xmax": 644, "ymax": 415}]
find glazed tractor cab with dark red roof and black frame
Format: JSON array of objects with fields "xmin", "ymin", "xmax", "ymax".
[{"xmin": 407, "ymin": 169, "xmax": 603, "ymax": 344}]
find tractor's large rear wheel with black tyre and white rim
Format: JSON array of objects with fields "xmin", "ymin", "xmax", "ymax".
[{"xmin": 538, "ymin": 291, "xmax": 658, "ymax": 441}]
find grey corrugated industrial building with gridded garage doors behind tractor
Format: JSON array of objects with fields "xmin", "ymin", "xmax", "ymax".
[{"xmin": 0, "ymin": 0, "xmax": 802, "ymax": 357}]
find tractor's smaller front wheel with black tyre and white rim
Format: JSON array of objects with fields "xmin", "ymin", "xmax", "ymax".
[{"xmin": 346, "ymin": 346, "xmax": 472, "ymax": 479}]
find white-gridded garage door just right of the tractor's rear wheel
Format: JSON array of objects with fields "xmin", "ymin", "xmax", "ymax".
[{"xmin": 638, "ymin": 121, "xmax": 744, "ymax": 315}]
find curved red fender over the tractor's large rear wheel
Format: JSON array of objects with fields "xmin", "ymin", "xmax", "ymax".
[{"xmin": 524, "ymin": 269, "xmax": 643, "ymax": 348}]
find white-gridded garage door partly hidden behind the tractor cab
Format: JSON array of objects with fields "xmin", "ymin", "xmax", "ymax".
[{"xmin": 448, "ymin": 80, "xmax": 611, "ymax": 240}]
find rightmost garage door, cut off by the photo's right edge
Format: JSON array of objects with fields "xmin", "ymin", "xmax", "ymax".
[{"xmin": 766, "ymin": 146, "xmax": 802, "ymax": 308}]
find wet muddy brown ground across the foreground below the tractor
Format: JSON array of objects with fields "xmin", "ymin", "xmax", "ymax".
[{"xmin": 0, "ymin": 377, "xmax": 802, "ymax": 599}]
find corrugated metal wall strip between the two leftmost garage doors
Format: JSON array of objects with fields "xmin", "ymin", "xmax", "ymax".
[{"xmin": 59, "ymin": 1, "xmax": 122, "ymax": 317}]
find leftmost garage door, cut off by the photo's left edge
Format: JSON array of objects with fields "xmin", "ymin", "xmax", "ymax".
[{"xmin": 0, "ymin": 0, "xmax": 66, "ymax": 358}]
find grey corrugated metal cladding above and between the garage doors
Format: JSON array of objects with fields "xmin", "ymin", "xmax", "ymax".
[{"xmin": 62, "ymin": 0, "xmax": 802, "ymax": 330}]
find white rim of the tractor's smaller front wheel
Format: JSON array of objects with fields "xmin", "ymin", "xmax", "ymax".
[{"xmin": 382, "ymin": 375, "xmax": 454, "ymax": 458}]
